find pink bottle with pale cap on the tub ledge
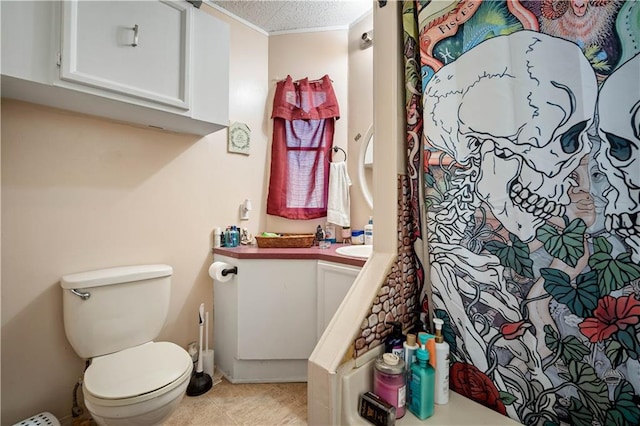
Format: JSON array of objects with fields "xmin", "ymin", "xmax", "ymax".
[{"xmin": 373, "ymin": 353, "xmax": 407, "ymax": 419}]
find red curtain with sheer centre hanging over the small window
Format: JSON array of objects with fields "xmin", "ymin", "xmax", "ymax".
[{"xmin": 267, "ymin": 75, "xmax": 340, "ymax": 219}]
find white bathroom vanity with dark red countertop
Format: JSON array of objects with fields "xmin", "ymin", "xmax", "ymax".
[{"xmin": 213, "ymin": 244, "xmax": 365, "ymax": 383}]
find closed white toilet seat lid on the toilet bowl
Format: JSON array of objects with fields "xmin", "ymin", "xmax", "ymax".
[{"xmin": 83, "ymin": 342, "xmax": 193, "ymax": 406}]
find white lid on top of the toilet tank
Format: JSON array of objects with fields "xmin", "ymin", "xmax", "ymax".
[{"xmin": 60, "ymin": 264, "xmax": 173, "ymax": 289}]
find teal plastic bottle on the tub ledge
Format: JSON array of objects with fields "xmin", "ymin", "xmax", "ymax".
[{"xmin": 408, "ymin": 348, "xmax": 436, "ymax": 420}]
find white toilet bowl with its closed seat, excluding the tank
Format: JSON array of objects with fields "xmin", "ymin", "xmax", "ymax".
[{"xmin": 83, "ymin": 342, "xmax": 193, "ymax": 425}]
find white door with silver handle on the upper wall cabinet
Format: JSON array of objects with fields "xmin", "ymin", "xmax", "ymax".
[{"xmin": 60, "ymin": 0, "xmax": 192, "ymax": 110}]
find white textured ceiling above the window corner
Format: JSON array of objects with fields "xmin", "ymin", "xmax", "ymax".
[{"xmin": 207, "ymin": 0, "xmax": 373, "ymax": 33}]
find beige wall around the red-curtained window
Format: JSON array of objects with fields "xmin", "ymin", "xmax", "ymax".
[{"xmin": 264, "ymin": 23, "xmax": 373, "ymax": 232}]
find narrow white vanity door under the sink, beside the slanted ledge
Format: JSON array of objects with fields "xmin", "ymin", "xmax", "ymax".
[{"xmin": 317, "ymin": 261, "xmax": 361, "ymax": 340}]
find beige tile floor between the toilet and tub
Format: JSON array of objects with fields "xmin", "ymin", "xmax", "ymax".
[{"xmin": 164, "ymin": 378, "xmax": 307, "ymax": 426}]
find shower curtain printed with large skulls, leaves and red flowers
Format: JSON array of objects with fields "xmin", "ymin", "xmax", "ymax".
[{"xmin": 403, "ymin": 0, "xmax": 640, "ymax": 426}]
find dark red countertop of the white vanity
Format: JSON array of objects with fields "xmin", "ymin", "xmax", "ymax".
[{"xmin": 213, "ymin": 243, "xmax": 366, "ymax": 267}]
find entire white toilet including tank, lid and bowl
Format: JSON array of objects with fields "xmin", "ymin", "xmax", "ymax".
[{"xmin": 60, "ymin": 265, "xmax": 193, "ymax": 425}]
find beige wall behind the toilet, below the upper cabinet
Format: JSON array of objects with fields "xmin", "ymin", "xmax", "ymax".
[{"xmin": 1, "ymin": 6, "xmax": 269, "ymax": 425}]
